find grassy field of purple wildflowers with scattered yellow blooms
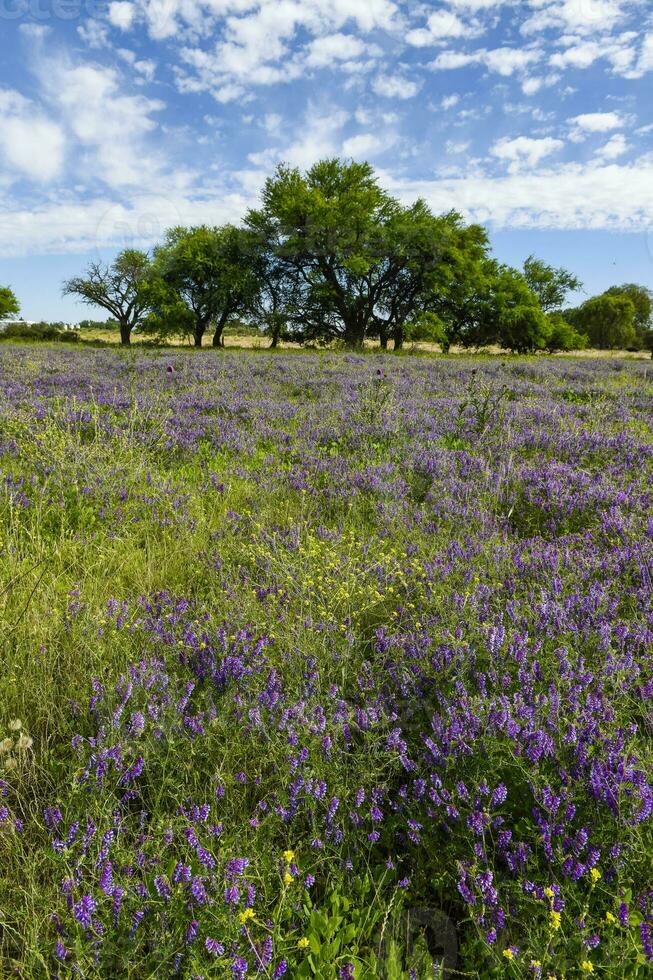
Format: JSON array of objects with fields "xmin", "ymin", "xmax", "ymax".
[{"xmin": 0, "ymin": 346, "xmax": 653, "ymax": 980}]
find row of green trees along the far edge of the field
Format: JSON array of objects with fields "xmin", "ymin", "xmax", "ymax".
[{"xmin": 5, "ymin": 159, "xmax": 651, "ymax": 352}]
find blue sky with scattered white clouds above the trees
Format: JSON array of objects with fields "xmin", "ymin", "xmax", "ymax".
[{"xmin": 0, "ymin": 0, "xmax": 653, "ymax": 320}]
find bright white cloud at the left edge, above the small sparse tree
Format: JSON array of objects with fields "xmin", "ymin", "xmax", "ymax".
[{"xmin": 0, "ymin": 89, "xmax": 65, "ymax": 181}]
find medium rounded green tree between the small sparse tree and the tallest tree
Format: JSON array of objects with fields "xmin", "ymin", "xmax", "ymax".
[{"xmin": 155, "ymin": 225, "xmax": 257, "ymax": 347}]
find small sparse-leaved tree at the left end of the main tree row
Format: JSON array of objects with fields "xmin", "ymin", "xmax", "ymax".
[{"xmin": 63, "ymin": 248, "xmax": 151, "ymax": 345}]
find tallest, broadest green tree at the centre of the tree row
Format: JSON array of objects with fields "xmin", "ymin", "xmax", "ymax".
[{"xmin": 247, "ymin": 159, "xmax": 464, "ymax": 347}]
